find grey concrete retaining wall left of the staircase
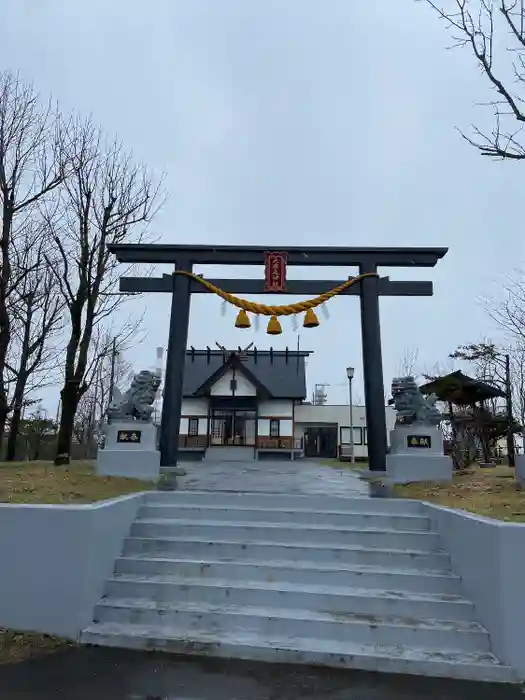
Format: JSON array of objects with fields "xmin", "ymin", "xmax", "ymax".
[{"xmin": 0, "ymin": 494, "xmax": 144, "ymax": 639}]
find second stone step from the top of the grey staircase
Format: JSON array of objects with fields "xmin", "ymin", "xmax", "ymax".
[{"xmin": 138, "ymin": 503, "xmax": 430, "ymax": 531}]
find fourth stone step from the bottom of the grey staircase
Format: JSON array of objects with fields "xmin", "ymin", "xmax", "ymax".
[{"xmin": 115, "ymin": 556, "xmax": 461, "ymax": 595}]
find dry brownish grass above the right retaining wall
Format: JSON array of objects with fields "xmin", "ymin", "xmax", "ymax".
[{"xmin": 395, "ymin": 466, "xmax": 525, "ymax": 522}]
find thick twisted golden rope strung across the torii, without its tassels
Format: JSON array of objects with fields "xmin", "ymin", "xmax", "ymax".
[{"xmin": 173, "ymin": 270, "xmax": 379, "ymax": 316}]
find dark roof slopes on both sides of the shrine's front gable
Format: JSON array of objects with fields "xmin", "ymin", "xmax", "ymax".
[{"xmin": 183, "ymin": 348, "xmax": 311, "ymax": 399}]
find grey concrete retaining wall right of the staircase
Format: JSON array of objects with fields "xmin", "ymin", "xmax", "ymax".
[{"xmin": 426, "ymin": 503, "xmax": 525, "ymax": 678}]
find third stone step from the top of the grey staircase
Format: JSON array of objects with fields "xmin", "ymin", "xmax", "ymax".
[{"xmin": 131, "ymin": 518, "xmax": 439, "ymax": 551}]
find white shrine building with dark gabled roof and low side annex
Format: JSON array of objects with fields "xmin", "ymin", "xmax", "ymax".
[{"xmin": 179, "ymin": 348, "xmax": 395, "ymax": 459}]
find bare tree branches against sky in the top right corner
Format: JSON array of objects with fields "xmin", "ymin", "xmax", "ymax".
[{"xmin": 423, "ymin": 0, "xmax": 525, "ymax": 160}]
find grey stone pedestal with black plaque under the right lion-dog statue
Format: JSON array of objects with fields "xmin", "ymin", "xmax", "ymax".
[{"xmin": 386, "ymin": 424, "xmax": 452, "ymax": 484}]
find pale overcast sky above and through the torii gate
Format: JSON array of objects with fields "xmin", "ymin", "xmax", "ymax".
[{"xmin": 0, "ymin": 0, "xmax": 525, "ymax": 404}]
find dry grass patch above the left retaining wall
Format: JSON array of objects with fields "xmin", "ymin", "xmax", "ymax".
[{"xmin": 0, "ymin": 461, "xmax": 153, "ymax": 503}]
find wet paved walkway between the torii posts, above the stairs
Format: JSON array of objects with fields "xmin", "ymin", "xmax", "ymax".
[{"xmin": 177, "ymin": 459, "xmax": 368, "ymax": 496}]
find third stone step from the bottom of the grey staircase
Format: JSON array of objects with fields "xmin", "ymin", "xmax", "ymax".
[{"xmin": 105, "ymin": 574, "xmax": 475, "ymax": 620}]
